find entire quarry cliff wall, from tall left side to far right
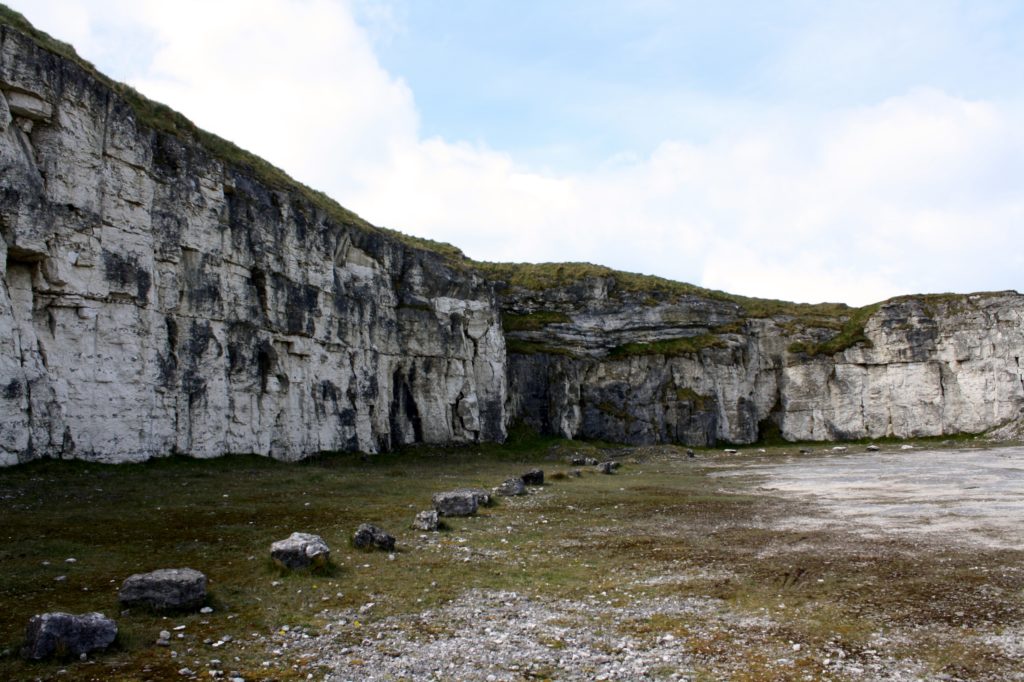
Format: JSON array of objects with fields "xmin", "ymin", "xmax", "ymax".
[{"xmin": 0, "ymin": 19, "xmax": 1024, "ymax": 465}]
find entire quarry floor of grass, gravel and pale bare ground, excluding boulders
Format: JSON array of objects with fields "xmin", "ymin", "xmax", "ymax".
[{"xmin": 0, "ymin": 439, "xmax": 1024, "ymax": 681}]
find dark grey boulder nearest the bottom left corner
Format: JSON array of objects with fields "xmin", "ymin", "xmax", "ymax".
[{"xmin": 22, "ymin": 611, "xmax": 118, "ymax": 660}]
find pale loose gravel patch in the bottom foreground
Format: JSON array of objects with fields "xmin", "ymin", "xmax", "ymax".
[{"xmin": 262, "ymin": 591, "xmax": 942, "ymax": 682}]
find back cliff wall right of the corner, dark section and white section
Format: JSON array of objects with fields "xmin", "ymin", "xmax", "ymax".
[{"xmin": 503, "ymin": 278, "xmax": 1024, "ymax": 445}]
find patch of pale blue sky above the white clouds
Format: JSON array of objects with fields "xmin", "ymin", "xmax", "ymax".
[{"xmin": 356, "ymin": 0, "xmax": 1024, "ymax": 168}]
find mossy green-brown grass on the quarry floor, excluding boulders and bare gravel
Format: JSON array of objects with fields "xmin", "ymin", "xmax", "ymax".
[{"xmin": 0, "ymin": 440, "xmax": 1024, "ymax": 680}]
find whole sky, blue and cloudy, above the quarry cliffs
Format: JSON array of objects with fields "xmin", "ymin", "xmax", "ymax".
[{"xmin": 6, "ymin": 0, "xmax": 1024, "ymax": 304}]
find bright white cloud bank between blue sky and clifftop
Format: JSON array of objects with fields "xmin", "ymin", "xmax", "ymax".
[{"xmin": 8, "ymin": 0, "xmax": 1024, "ymax": 303}]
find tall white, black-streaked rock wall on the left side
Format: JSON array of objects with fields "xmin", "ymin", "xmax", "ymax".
[{"xmin": 0, "ymin": 28, "xmax": 506, "ymax": 464}]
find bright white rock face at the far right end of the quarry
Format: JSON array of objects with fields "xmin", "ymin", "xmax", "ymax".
[{"xmin": 780, "ymin": 293, "xmax": 1024, "ymax": 440}]
